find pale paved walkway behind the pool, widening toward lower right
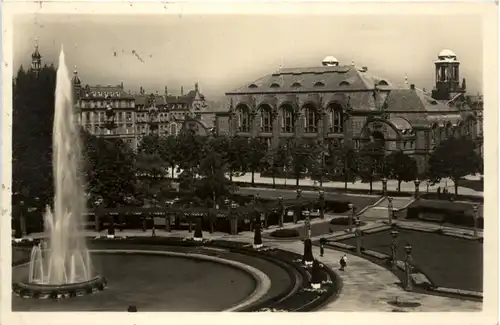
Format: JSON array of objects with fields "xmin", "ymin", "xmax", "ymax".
[{"xmin": 21, "ymin": 216, "xmax": 482, "ymax": 312}]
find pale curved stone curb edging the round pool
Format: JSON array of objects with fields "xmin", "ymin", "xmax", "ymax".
[{"xmin": 90, "ymin": 249, "xmax": 271, "ymax": 312}]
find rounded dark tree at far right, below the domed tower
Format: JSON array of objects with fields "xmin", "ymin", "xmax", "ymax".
[{"xmin": 429, "ymin": 137, "xmax": 483, "ymax": 195}]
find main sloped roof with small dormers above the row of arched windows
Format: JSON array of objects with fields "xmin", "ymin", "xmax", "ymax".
[{"xmin": 228, "ymin": 66, "xmax": 391, "ymax": 94}]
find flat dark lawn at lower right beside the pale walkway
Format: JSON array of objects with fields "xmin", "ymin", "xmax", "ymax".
[{"xmin": 341, "ymin": 230, "xmax": 483, "ymax": 292}]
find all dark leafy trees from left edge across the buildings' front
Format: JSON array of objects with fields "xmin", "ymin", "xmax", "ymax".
[{"xmin": 12, "ymin": 66, "xmax": 482, "ymax": 205}]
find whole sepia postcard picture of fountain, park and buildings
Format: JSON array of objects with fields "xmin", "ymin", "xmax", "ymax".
[{"xmin": 2, "ymin": 0, "xmax": 498, "ymax": 324}]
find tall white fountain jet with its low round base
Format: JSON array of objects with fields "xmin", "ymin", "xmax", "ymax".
[{"xmin": 14, "ymin": 49, "xmax": 106, "ymax": 298}]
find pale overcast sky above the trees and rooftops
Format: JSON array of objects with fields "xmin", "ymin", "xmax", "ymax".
[{"xmin": 13, "ymin": 15, "xmax": 482, "ymax": 100}]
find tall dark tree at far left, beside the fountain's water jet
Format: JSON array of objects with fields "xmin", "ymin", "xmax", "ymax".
[{"xmin": 12, "ymin": 65, "xmax": 56, "ymax": 200}]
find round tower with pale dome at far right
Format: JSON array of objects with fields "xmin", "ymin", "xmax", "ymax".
[{"xmin": 432, "ymin": 49, "xmax": 465, "ymax": 100}]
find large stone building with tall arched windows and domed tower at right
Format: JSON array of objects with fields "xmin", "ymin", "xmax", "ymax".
[{"xmin": 223, "ymin": 50, "xmax": 483, "ymax": 169}]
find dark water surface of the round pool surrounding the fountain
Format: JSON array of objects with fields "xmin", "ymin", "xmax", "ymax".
[{"xmin": 12, "ymin": 253, "xmax": 256, "ymax": 312}]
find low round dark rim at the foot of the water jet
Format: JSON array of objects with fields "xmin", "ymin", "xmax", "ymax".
[{"xmin": 12, "ymin": 276, "xmax": 107, "ymax": 299}]
